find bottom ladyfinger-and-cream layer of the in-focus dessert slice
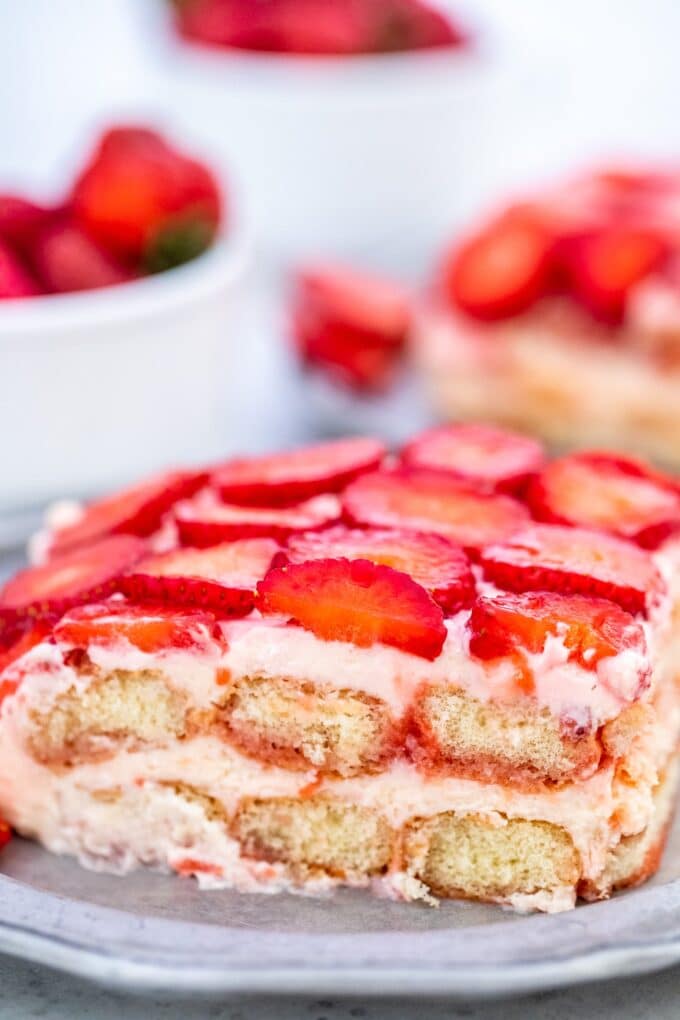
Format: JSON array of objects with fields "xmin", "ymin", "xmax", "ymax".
[{"xmin": 0, "ymin": 722, "xmax": 678, "ymax": 911}]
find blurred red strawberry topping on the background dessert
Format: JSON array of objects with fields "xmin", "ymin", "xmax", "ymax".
[{"xmin": 441, "ymin": 170, "xmax": 680, "ymax": 326}]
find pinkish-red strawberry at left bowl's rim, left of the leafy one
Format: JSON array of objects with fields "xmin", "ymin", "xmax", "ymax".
[{"xmin": 32, "ymin": 222, "xmax": 134, "ymax": 294}]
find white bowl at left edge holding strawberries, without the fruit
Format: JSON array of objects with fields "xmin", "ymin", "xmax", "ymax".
[{"xmin": 0, "ymin": 232, "xmax": 250, "ymax": 511}]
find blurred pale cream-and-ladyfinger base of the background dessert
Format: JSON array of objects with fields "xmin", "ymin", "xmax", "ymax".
[{"xmin": 415, "ymin": 317, "xmax": 680, "ymax": 465}]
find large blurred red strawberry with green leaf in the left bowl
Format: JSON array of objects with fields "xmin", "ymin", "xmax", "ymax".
[{"xmin": 71, "ymin": 128, "xmax": 221, "ymax": 272}]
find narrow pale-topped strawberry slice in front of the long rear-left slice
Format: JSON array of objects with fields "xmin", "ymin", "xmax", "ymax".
[{"xmin": 174, "ymin": 496, "xmax": 341, "ymax": 549}]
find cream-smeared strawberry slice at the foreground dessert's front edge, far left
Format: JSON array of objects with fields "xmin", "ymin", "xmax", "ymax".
[{"xmin": 54, "ymin": 602, "xmax": 215, "ymax": 655}]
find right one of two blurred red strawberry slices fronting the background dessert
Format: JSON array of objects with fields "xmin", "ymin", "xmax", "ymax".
[{"xmin": 560, "ymin": 224, "xmax": 669, "ymax": 325}]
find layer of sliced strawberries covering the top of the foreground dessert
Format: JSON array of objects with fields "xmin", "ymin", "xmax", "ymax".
[{"xmin": 0, "ymin": 426, "xmax": 680, "ymax": 667}]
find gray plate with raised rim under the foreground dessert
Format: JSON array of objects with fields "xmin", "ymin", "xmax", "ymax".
[{"xmin": 0, "ymin": 825, "xmax": 680, "ymax": 998}]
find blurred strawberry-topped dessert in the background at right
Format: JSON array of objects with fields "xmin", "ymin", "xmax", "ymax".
[{"xmin": 414, "ymin": 167, "xmax": 680, "ymax": 467}]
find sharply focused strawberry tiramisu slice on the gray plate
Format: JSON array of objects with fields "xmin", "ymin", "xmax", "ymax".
[{"xmin": 0, "ymin": 425, "xmax": 680, "ymax": 911}]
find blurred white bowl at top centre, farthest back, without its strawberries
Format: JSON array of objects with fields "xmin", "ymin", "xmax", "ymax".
[{"xmin": 140, "ymin": 0, "xmax": 487, "ymax": 270}]
